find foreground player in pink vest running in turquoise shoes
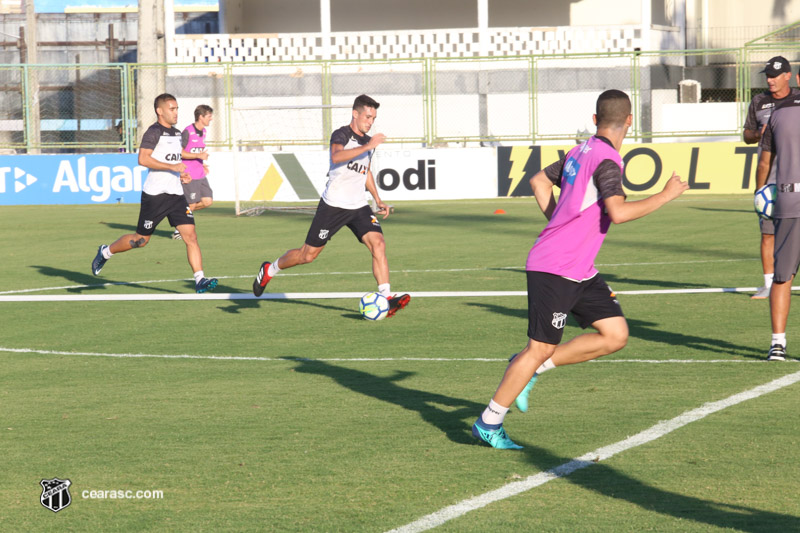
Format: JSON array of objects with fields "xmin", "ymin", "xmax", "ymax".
[{"xmin": 472, "ymin": 90, "xmax": 689, "ymax": 449}]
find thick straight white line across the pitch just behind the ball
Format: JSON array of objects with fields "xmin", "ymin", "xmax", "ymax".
[{"xmin": 0, "ymin": 286, "xmax": 800, "ymax": 303}]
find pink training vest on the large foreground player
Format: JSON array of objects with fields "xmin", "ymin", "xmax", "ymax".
[{"xmin": 525, "ymin": 136, "xmax": 623, "ymax": 281}]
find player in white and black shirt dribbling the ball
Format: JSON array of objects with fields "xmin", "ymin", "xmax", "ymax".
[{"xmin": 253, "ymin": 94, "xmax": 411, "ymax": 316}]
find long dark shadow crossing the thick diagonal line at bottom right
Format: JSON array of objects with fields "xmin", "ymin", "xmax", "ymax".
[{"xmin": 512, "ymin": 441, "xmax": 800, "ymax": 533}]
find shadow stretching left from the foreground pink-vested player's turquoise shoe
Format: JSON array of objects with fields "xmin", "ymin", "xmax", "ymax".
[{"xmin": 285, "ymin": 357, "xmax": 486, "ymax": 444}]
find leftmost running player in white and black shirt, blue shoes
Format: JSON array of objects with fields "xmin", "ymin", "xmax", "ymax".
[{"xmin": 92, "ymin": 93, "xmax": 217, "ymax": 293}]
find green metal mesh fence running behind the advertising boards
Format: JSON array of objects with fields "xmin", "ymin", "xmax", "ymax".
[{"xmin": 0, "ymin": 39, "xmax": 800, "ymax": 152}]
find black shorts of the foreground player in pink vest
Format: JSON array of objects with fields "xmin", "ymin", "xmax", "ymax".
[{"xmin": 526, "ymin": 272, "xmax": 625, "ymax": 344}]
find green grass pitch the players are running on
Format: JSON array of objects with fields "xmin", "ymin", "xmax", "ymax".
[{"xmin": 0, "ymin": 197, "xmax": 800, "ymax": 532}]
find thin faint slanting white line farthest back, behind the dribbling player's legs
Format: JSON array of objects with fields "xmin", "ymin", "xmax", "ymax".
[{"xmin": 0, "ymin": 258, "xmax": 758, "ymax": 295}]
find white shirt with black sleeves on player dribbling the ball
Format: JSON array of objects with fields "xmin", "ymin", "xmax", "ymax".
[{"xmin": 322, "ymin": 125, "xmax": 375, "ymax": 209}]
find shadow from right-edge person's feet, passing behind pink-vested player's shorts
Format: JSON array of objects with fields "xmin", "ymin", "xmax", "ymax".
[{"xmin": 466, "ymin": 302, "xmax": 764, "ymax": 359}]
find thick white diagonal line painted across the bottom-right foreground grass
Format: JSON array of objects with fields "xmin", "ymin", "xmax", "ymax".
[{"xmin": 390, "ymin": 372, "xmax": 800, "ymax": 533}]
